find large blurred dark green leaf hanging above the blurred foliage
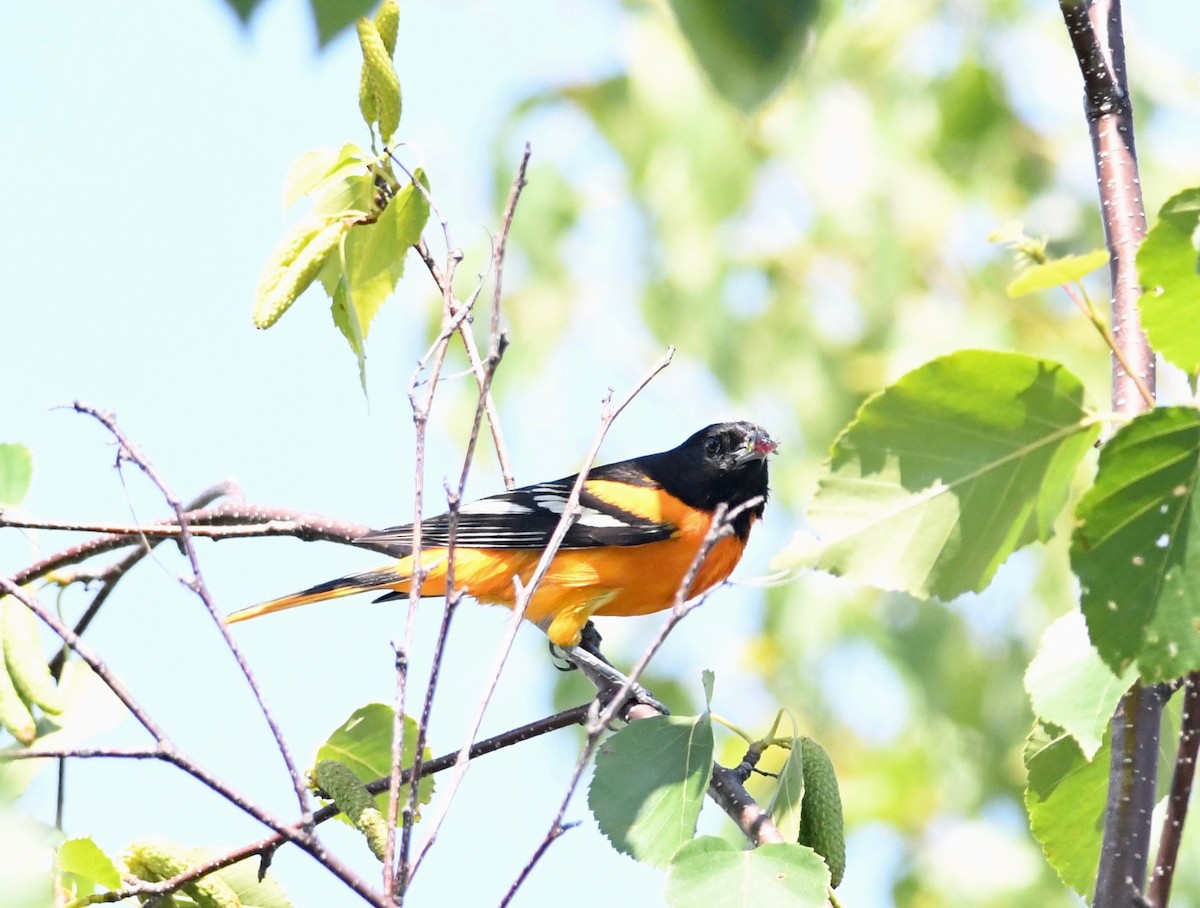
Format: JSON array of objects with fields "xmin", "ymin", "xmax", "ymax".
[{"xmin": 671, "ymin": 0, "xmax": 821, "ymax": 113}]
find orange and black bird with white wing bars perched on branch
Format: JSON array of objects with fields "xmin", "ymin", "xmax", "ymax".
[{"xmin": 226, "ymin": 422, "xmax": 776, "ymax": 648}]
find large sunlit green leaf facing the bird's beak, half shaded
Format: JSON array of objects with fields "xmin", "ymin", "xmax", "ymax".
[{"xmin": 809, "ymin": 350, "xmax": 1098, "ymax": 599}]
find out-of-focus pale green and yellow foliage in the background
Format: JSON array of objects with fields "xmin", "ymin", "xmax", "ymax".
[{"xmin": 480, "ymin": 0, "xmax": 1200, "ymax": 906}]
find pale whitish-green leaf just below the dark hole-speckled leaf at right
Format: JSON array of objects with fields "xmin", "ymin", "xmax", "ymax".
[{"xmin": 1025, "ymin": 612, "xmax": 1138, "ymax": 759}]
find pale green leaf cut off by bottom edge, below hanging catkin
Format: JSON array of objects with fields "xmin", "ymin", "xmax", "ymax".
[{"xmin": 666, "ymin": 836, "xmax": 829, "ymax": 908}]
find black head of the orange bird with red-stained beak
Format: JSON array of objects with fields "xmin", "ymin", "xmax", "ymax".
[{"xmin": 646, "ymin": 422, "xmax": 776, "ymax": 539}]
